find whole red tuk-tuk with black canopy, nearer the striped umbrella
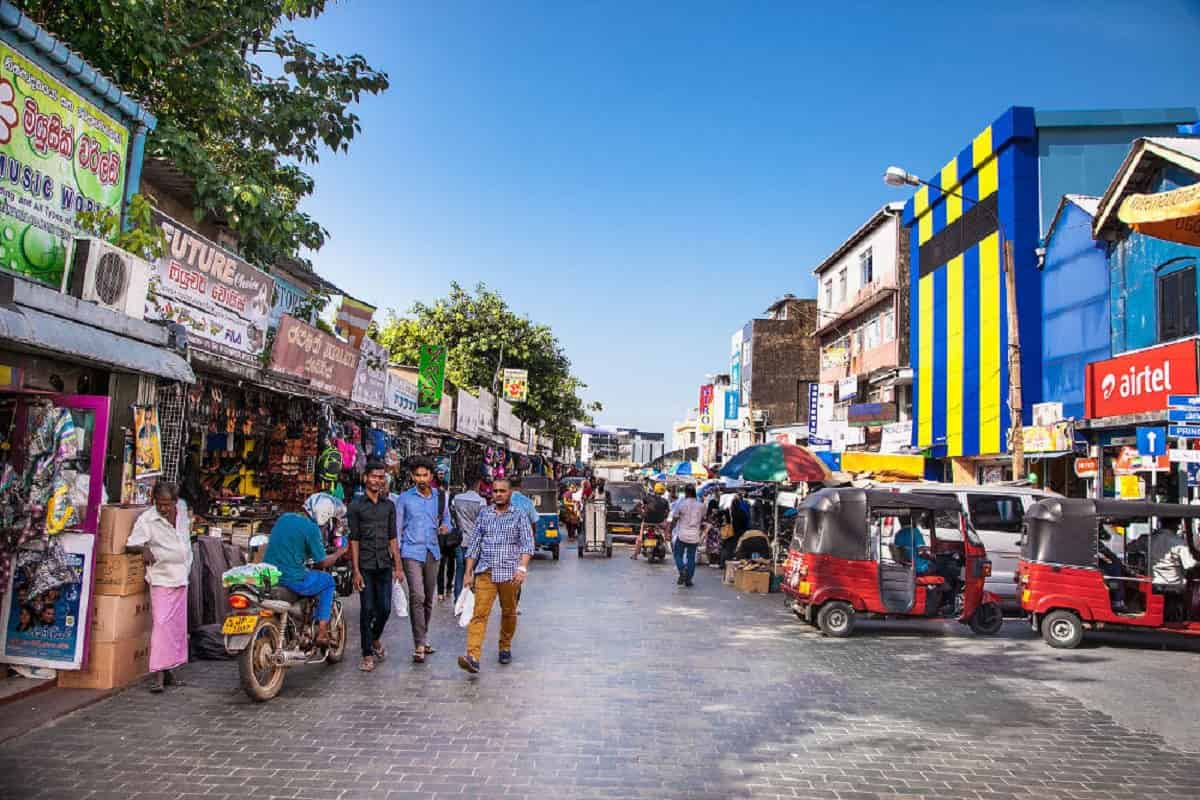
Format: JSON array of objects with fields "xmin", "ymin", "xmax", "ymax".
[{"xmin": 784, "ymin": 488, "xmax": 1004, "ymax": 637}]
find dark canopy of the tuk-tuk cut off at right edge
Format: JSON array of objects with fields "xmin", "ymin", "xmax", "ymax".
[{"xmin": 1021, "ymin": 498, "xmax": 1200, "ymax": 566}]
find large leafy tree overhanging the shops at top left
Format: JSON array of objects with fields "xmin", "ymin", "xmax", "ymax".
[{"xmin": 18, "ymin": 0, "xmax": 388, "ymax": 266}]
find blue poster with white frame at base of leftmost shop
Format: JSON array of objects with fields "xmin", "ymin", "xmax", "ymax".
[{"xmin": 0, "ymin": 534, "xmax": 96, "ymax": 669}]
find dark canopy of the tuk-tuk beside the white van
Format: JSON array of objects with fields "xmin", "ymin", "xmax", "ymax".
[{"xmin": 794, "ymin": 488, "xmax": 962, "ymax": 561}]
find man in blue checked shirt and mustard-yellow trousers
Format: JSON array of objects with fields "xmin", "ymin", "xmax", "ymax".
[{"xmin": 458, "ymin": 479, "xmax": 533, "ymax": 673}]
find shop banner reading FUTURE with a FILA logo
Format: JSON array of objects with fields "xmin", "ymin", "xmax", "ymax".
[{"xmin": 146, "ymin": 211, "xmax": 275, "ymax": 361}]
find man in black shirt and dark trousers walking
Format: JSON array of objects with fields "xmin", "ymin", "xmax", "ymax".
[{"xmin": 346, "ymin": 461, "xmax": 404, "ymax": 672}]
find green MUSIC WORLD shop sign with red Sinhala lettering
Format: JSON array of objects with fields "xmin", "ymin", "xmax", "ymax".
[{"xmin": 0, "ymin": 42, "xmax": 130, "ymax": 287}]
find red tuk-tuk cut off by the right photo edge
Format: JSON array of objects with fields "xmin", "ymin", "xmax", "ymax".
[{"xmin": 1016, "ymin": 498, "xmax": 1200, "ymax": 648}]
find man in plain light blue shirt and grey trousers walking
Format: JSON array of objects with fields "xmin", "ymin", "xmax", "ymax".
[{"xmin": 395, "ymin": 458, "xmax": 450, "ymax": 663}]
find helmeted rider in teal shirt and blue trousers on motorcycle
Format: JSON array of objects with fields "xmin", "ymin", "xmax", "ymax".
[{"xmin": 263, "ymin": 492, "xmax": 346, "ymax": 646}]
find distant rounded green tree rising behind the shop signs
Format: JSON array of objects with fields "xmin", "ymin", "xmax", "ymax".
[{"xmin": 379, "ymin": 283, "xmax": 602, "ymax": 444}]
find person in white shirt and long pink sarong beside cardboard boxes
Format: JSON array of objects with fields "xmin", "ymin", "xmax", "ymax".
[{"xmin": 125, "ymin": 481, "xmax": 192, "ymax": 692}]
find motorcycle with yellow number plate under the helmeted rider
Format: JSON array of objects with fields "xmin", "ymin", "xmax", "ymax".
[{"xmin": 221, "ymin": 537, "xmax": 350, "ymax": 702}]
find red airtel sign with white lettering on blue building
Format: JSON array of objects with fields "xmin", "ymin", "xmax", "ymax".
[{"xmin": 1086, "ymin": 339, "xmax": 1198, "ymax": 419}]
